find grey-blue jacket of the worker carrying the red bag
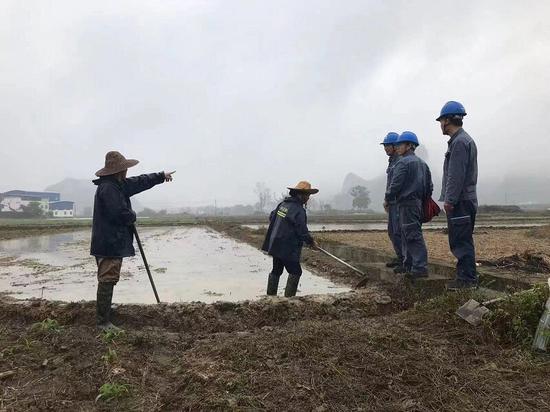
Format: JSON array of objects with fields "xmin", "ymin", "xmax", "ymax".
[{"xmin": 385, "ymin": 152, "xmax": 433, "ymax": 204}]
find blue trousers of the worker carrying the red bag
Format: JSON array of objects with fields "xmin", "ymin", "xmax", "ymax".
[{"xmin": 398, "ymin": 200, "xmax": 428, "ymax": 275}]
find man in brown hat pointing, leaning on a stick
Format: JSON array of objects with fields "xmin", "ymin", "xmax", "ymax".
[{"xmin": 90, "ymin": 152, "xmax": 174, "ymax": 330}]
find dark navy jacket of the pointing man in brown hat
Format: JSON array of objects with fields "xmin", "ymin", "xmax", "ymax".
[{"xmin": 90, "ymin": 172, "xmax": 165, "ymax": 258}]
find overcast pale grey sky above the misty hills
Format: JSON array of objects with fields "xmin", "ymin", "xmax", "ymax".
[{"xmin": 0, "ymin": 0, "xmax": 550, "ymax": 207}]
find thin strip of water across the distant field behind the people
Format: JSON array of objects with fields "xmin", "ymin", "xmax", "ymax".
[{"xmin": 242, "ymin": 222, "xmax": 547, "ymax": 232}]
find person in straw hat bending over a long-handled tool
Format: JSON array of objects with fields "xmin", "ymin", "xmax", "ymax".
[{"xmin": 262, "ymin": 181, "xmax": 319, "ymax": 297}]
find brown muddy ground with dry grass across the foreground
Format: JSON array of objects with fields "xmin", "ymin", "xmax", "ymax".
[{"xmin": 0, "ymin": 226, "xmax": 550, "ymax": 412}]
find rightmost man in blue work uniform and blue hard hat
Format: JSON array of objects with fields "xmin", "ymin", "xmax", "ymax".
[{"xmin": 436, "ymin": 101, "xmax": 477, "ymax": 290}]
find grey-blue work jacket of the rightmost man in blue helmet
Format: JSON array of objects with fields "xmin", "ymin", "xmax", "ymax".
[{"xmin": 439, "ymin": 128, "xmax": 477, "ymax": 205}]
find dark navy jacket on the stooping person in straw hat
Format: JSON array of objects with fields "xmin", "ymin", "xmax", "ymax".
[{"xmin": 262, "ymin": 197, "xmax": 313, "ymax": 262}]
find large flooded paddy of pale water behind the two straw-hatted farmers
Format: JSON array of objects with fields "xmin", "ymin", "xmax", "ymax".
[{"xmin": 0, "ymin": 227, "xmax": 349, "ymax": 303}]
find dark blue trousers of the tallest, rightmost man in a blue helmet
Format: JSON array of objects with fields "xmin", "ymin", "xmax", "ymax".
[{"xmin": 447, "ymin": 200, "xmax": 477, "ymax": 282}]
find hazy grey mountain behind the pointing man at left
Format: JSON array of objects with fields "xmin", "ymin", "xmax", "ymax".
[{"xmin": 45, "ymin": 178, "xmax": 143, "ymax": 216}]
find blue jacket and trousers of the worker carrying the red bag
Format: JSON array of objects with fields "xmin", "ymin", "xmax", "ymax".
[{"xmin": 385, "ymin": 152, "xmax": 433, "ymax": 277}]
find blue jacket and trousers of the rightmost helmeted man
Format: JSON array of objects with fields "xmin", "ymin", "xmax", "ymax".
[{"xmin": 439, "ymin": 128, "xmax": 477, "ymax": 283}]
